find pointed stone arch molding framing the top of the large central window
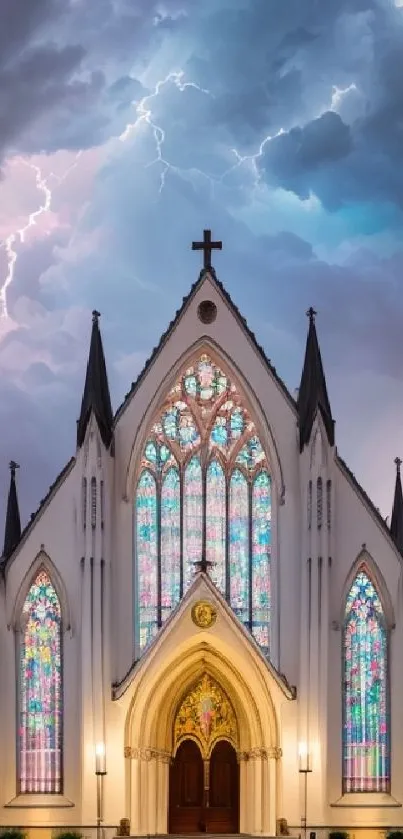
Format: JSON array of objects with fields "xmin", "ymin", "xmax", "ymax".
[{"xmin": 123, "ymin": 337, "xmax": 285, "ymax": 504}]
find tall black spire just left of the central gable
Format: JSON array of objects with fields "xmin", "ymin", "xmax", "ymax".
[{"xmin": 77, "ymin": 310, "xmax": 113, "ymax": 448}]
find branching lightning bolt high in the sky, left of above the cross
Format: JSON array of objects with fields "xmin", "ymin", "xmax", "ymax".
[{"xmin": 119, "ymin": 70, "xmax": 212, "ymax": 194}]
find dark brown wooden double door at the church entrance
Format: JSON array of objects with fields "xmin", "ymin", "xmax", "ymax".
[{"xmin": 169, "ymin": 740, "xmax": 239, "ymax": 833}]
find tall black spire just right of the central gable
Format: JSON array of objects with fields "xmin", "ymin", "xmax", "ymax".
[{"xmin": 298, "ymin": 306, "xmax": 334, "ymax": 452}]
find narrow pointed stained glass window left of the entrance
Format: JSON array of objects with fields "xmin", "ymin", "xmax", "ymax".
[{"xmin": 18, "ymin": 570, "xmax": 63, "ymax": 793}]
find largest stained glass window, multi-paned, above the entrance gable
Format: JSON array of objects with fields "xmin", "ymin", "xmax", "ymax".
[{"xmin": 135, "ymin": 354, "xmax": 271, "ymax": 654}]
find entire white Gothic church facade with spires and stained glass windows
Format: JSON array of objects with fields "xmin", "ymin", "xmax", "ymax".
[{"xmin": 0, "ymin": 265, "xmax": 403, "ymax": 836}]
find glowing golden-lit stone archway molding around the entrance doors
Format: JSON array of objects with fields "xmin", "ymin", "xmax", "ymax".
[{"xmin": 125, "ymin": 642, "xmax": 281, "ymax": 835}]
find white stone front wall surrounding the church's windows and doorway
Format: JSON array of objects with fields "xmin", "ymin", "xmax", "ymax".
[{"xmin": 0, "ymin": 278, "xmax": 403, "ymax": 833}]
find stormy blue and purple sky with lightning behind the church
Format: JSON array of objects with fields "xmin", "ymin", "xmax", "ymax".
[{"xmin": 0, "ymin": 0, "xmax": 403, "ymax": 521}]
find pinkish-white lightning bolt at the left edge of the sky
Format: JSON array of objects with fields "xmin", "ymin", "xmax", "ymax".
[{"xmin": 0, "ymin": 151, "xmax": 82, "ymax": 318}]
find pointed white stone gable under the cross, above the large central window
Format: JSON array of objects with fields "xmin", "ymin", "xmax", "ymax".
[{"xmin": 116, "ymin": 269, "xmax": 297, "ymax": 506}]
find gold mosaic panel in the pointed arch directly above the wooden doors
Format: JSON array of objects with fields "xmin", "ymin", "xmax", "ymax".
[{"xmin": 174, "ymin": 673, "xmax": 238, "ymax": 757}]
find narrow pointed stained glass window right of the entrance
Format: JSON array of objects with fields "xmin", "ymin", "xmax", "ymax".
[{"xmin": 343, "ymin": 566, "xmax": 390, "ymax": 792}]
